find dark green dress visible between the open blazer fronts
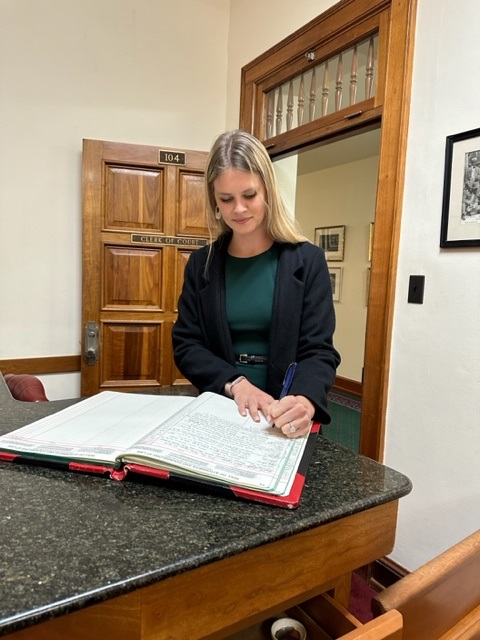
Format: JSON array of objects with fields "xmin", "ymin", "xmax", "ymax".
[{"xmin": 225, "ymin": 245, "xmax": 278, "ymax": 390}]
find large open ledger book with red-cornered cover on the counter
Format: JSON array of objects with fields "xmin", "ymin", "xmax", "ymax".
[{"xmin": 0, "ymin": 391, "xmax": 318, "ymax": 508}]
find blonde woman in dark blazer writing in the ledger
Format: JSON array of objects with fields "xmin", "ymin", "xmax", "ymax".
[{"xmin": 173, "ymin": 131, "xmax": 340, "ymax": 438}]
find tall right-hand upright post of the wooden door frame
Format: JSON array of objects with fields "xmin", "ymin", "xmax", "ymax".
[{"xmin": 360, "ymin": 0, "xmax": 416, "ymax": 462}]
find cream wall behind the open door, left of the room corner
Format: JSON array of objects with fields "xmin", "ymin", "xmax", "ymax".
[{"xmin": 0, "ymin": 0, "xmax": 230, "ymax": 399}]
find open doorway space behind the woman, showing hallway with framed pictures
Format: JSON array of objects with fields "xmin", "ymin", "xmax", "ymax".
[{"xmin": 274, "ymin": 126, "xmax": 380, "ymax": 451}]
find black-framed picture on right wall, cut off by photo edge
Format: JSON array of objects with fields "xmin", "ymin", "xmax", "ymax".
[{"xmin": 440, "ymin": 129, "xmax": 480, "ymax": 247}]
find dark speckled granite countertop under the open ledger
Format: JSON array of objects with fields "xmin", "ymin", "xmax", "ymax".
[{"xmin": 0, "ymin": 375, "xmax": 411, "ymax": 635}]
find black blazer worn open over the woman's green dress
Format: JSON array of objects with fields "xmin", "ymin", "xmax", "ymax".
[{"xmin": 173, "ymin": 236, "xmax": 340, "ymax": 424}]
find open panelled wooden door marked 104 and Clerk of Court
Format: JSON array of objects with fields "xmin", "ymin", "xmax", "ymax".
[{"xmin": 81, "ymin": 140, "xmax": 208, "ymax": 396}]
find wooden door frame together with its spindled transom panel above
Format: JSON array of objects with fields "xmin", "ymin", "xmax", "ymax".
[{"xmin": 240, "ymin": 0, "xmax": 417, "ymax": 461}]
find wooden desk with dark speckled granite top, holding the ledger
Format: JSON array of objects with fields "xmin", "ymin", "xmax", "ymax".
[{"xmin": 0, "ymin": 379, "xmax": 411, "ymax": 640}]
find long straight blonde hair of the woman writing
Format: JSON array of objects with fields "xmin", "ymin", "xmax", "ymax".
[{"xmin": 205, "ymin": 129, "xmax": 307, "ymax": 243}]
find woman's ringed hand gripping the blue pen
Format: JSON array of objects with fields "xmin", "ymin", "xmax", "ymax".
[{"xmin": 265, "ymin": 396, "xmax": 315, "ymax": 438}]
